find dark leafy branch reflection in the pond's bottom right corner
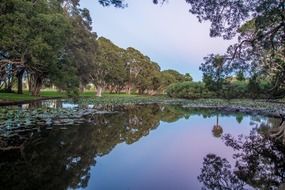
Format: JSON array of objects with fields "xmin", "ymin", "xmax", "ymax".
[{"xmin": 198, "ymin": 124, "xmax": 285, "ymax": 189}]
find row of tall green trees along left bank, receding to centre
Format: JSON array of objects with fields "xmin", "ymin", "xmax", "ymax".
[{"xmin": 0, "ymin": 0, "xmax": 192, "ymax": 96}]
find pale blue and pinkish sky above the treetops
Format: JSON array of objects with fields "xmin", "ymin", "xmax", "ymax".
[{"xmin": 80, "ymin": 0, "xmax": 233, "ymax": 81}]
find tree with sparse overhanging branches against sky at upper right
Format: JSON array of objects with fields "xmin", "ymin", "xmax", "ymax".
[{"xmin": 186, "ymin": 0, "xmax": 285, "ymax": 95}]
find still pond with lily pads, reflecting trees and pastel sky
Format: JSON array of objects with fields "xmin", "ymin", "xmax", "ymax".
[{"xmin": 0, "ymin": 101, "xmax": 285, "ymax": 190}]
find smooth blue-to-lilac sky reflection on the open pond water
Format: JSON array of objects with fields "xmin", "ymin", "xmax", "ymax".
[{"xmin": 87, "ymin": 116, "xmax": 252, "ymax": 190}]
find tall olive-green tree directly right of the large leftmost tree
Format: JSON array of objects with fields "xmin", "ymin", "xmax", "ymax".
[{"xmin": 61, "ymin": 4, "xmax": 98, "ymax": 92}]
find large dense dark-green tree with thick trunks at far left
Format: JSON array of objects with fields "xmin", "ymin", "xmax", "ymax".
[{"xmin": 0, "ymin": 0, "xmax": 70, "ymax": 95}]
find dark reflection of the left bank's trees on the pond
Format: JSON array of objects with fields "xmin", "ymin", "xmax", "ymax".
[{"xmin": 0, "ymin": 105, "xmax": 169, "ymax": 190}]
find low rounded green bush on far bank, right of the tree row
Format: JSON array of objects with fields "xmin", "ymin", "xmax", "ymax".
[{"xmin": 166, "ymin": 82, "xmax": 215, "ymax": 99}]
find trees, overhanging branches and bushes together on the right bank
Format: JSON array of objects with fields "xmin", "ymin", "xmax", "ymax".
[{"xmin": 96, "ymin": 0, "xmax": 285, "ymax": 98}]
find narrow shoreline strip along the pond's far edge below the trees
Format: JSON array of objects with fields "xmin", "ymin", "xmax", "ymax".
[{"xmin": 0, "ymin": 95, "xmax": 285, "ymax": 118}]
